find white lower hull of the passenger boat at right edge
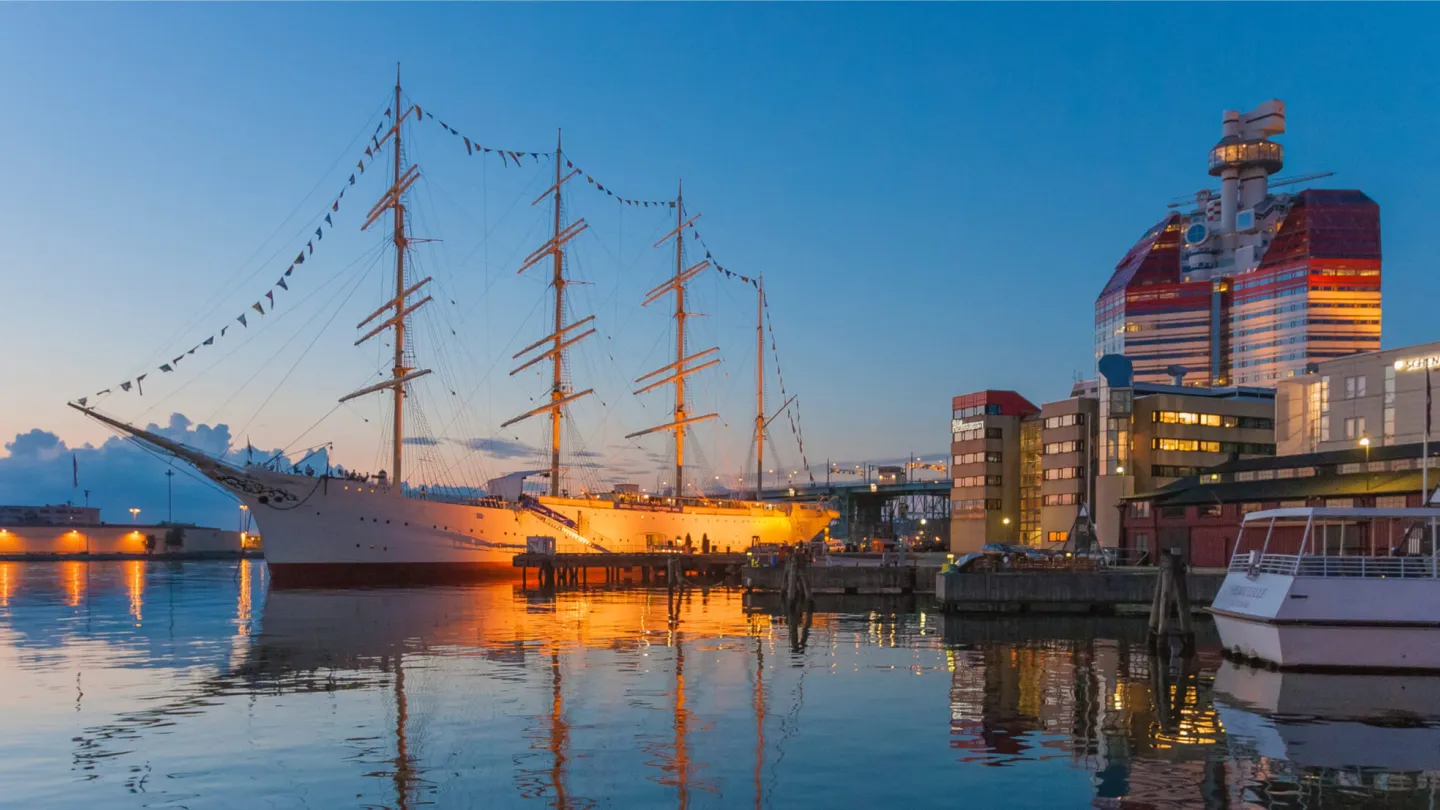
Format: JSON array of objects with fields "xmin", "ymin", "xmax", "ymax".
[{"xmin": 1211, "ymin": 571, "xmax": 1440, "ymax": 670}]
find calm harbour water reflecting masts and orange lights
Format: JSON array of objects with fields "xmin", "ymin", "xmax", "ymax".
[{"xmin": 0, "ymin": 562, "xmax": 1440, "ymax": 809}]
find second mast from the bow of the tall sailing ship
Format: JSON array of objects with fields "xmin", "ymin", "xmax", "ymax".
[{"xmin": 500, "ymin": 134, "xmax": 595, "ymax": 496}]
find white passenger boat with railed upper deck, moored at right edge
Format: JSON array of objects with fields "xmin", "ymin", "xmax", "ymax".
[{"xmin": 1210, "ymin": 507, "xmax": 1440, "ymax": 670}]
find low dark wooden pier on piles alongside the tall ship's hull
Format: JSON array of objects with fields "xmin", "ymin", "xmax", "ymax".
[{"xmin": 513, "ymin": 552, "xmax": 747, "ymax": 588}]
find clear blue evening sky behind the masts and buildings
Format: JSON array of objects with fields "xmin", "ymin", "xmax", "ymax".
[{"xmin": 0, "ymin": 4, "xmax": 1440, "ymax": 518}]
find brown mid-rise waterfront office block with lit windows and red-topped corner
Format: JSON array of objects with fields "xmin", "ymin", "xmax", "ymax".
[{"xmin": 950, "ymin": 356, "xmax": 1276, "ymax": 553}]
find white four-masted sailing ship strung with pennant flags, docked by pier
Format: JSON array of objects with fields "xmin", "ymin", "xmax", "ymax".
[{"xmin": 71, "ymin": 72, "xmax": 838, "ymax": 585}]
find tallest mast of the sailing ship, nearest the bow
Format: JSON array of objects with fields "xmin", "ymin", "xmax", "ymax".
[{"xmin": 340, "ymin": 63, "xmax": 431, "ymax": 494}]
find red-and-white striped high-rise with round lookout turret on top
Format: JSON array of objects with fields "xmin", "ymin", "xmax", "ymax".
[{"xmin": 1094, "ymin": 101, "xmax": 1381, "ymax": 386}]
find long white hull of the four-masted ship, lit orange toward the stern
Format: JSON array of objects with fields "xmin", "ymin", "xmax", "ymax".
[{"xmin": 206, "ymin": 468, "xmax": 834, "ymax": 584}]
